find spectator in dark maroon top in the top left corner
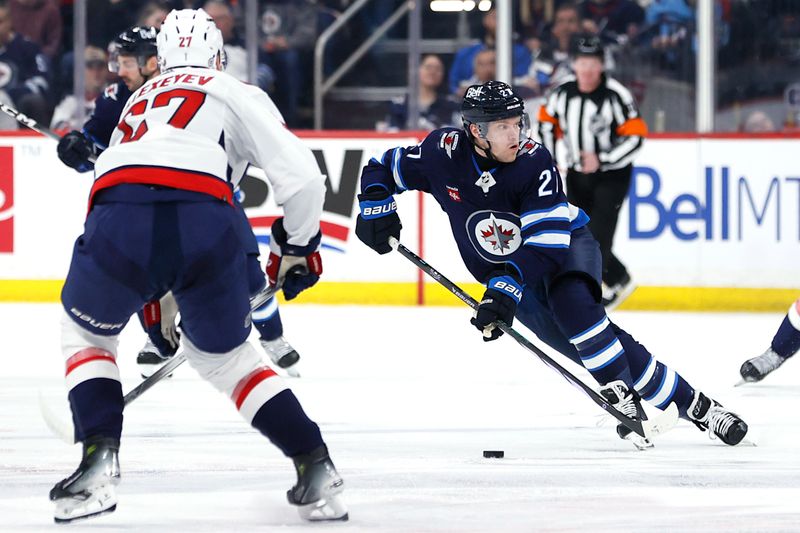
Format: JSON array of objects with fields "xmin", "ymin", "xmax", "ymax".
[{"xmin": 8, "ymin": 0, "xmax": 62, "ymax": 60}]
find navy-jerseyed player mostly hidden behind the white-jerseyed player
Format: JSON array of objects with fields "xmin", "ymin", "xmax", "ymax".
[{"xmin": 58, "ymin": 26, "xmax": 300, "ymax": 377}]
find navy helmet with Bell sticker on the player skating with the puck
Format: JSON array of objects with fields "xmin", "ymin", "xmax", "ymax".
[{"xmin": 461, "ymin": 80, "xmax": 528, "ymax": 141}]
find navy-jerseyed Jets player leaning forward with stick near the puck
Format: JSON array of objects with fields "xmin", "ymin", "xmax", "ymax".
[{"xmin": 356, "ymin": 81, "xmax": 747, "ymax": 446}]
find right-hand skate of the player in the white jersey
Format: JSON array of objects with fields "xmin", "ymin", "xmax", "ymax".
[{"xmin": 286, "ymin": 444, "xmax": 348, "ymax": 522}]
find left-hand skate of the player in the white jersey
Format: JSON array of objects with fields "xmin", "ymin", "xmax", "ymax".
[{"xmin": 50, "ymin": 437, "xmax": 119, "ymax": 524}]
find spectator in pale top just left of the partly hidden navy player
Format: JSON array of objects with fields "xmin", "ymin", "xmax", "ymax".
[{"xmin": 50, "ymin": 46, "xmax": 108, "ymax": 130}]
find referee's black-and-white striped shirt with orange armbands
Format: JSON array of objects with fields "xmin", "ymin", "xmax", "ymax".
[{"xmin": 539, "ymin": 74, "xmax": 647, "ymax": 172}]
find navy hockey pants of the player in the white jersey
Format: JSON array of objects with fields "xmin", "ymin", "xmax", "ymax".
[{"xmin": 61, "ymin": 197, "xmax": 250, "ymax": 353}]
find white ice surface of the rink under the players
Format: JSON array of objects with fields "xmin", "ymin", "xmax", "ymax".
[{"xmin": 0, "ymin": 302, "xmax": 800, "ymax": 533}]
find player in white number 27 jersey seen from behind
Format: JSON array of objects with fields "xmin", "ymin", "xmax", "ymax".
[{"xmin": 50, "ymin": 10, "xmax": 348, "ymax": 522}]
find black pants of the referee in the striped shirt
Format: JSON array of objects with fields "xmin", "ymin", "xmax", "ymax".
[{"xmin": 567, "ymin": 165, "xmax": 633, "ymax": 287}]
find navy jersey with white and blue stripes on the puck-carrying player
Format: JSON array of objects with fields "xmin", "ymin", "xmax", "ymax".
[{"xmin": 361, "ymin": 128, "xmax": 589, "ymax": 284}]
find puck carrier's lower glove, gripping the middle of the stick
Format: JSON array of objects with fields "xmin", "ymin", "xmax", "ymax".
[{"xmin": 470, "ymin": 267, "xmax": 522, "ymax": 342}]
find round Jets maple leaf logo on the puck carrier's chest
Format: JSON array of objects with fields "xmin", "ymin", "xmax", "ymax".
[{"xmin": 466, "ymin": 211, "xmax": 522, "ymax": 263}]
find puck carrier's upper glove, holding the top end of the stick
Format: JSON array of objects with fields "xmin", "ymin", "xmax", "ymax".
[{"xmin": 356, "ymin": 189, "xmax": 403, "ymax": 254}]
